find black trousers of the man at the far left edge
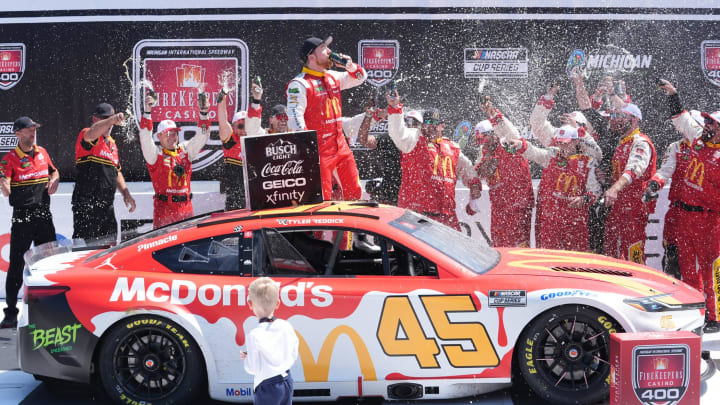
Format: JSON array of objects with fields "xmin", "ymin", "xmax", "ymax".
[{"xmin": 5, "ymin": 206, "xmax": 55, "ymax": 310}]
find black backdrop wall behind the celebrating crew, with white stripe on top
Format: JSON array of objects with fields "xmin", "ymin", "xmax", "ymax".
[{"xmin": 0, "ymin": 9, "xmax": 720, "ymax": 181}]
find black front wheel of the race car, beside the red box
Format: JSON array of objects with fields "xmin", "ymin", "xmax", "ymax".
[{"xmin": 516, "ymin": 305, "xmax": 622, "ymax": 404}]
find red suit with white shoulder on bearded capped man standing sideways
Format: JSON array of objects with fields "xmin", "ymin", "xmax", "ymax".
[{"xmin": 604, "ymin": 128, "xmax": 656, "ymax": 264}]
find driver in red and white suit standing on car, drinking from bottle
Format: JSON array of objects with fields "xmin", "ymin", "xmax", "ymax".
[{"xmin": 286, "ymin": 37, "xmax": 367, "ymax": 200}]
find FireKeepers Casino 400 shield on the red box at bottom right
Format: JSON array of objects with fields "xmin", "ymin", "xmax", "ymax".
[{"xmin": 632, "ymin": 344, "xmax": 690, "ymax": 405}]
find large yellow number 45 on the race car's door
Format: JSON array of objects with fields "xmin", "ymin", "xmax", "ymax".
[{"xmin": 377, "ymin": 295, "xmax": 500, "ymax": 368}]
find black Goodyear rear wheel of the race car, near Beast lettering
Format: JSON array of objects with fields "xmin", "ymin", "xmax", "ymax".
[{"xmin": 98, "ymin": 315, "xmax": 205, "ymax": 405}]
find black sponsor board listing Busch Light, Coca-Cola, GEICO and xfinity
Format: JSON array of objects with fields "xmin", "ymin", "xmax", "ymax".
[{"xmin": 240, "ymin": 131, "xmax": 322, "ymax": 210}]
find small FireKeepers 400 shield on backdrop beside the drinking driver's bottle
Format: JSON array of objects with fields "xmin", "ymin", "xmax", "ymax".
[{"xmin": 358, "ymin": 39, "xmax": 400, "ymax": 87}]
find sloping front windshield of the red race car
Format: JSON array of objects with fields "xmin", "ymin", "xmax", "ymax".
[{"xmin": 390, "ymin": 211, "xmax": 500, "ymax": 274}]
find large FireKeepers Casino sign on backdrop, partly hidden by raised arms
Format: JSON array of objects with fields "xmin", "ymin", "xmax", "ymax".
[{"xmin": 132, "ymin": 38, "xmax": 248, "ymax": 171}]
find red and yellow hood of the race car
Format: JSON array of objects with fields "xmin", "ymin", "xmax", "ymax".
[{"xmin": 486, "ymin": 248, "xmax": 704, "ymax": 304}]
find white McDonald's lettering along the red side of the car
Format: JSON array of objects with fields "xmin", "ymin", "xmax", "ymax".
[{"xmin": 110, "ymin": 277, "xmax": 333, "ymax": 307}]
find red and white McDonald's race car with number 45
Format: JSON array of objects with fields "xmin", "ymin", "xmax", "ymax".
[{"xmin": 18, "ymin": 202, "xmax": 705, "ymax": 404}]
